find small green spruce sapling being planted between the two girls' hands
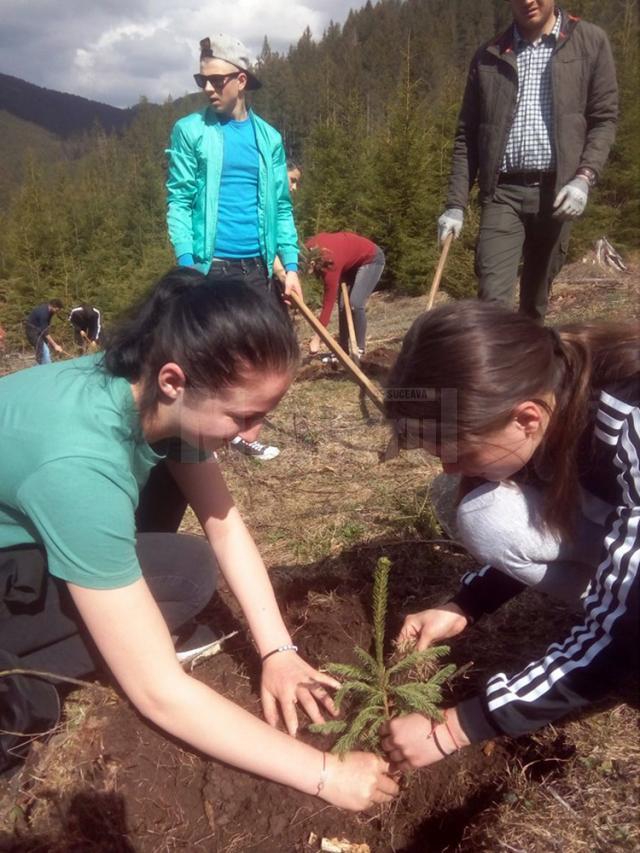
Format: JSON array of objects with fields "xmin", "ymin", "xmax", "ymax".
[{"xmin": 309, "ymin": 557, "xmax": 456, "ymax": 754}]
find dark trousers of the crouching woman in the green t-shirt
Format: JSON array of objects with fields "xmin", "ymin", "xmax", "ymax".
[{"xmin": 0, "ymin": 464, "xmax": 217, "ymax": 773}]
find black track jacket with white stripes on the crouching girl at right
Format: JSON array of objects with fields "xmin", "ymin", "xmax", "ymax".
[{"xmin": 454, "ymin": 376, "xmax": 640, "ymax": 741}]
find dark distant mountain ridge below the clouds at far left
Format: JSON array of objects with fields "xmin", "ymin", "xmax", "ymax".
[{"xmin": 0, "ymin": 74, "xmax": 136, "ymax": 139}]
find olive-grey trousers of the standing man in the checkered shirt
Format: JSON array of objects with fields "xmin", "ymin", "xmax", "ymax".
[{"xmin": 476, "ymin": 184, "xmax": 571, "ymax": 321}]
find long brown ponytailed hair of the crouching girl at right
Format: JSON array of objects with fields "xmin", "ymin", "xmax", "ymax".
[{"xmin": 385, "ymin": 300, "xmax": 640, "ymax": 533}]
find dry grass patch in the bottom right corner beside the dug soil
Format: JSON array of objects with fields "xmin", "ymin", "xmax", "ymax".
[{"xmin": 463, "ymin": 704, "xmax": 640, "ymax": 853}]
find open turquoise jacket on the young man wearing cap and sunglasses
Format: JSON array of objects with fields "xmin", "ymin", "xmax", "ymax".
[{"xmin": 166, "ymin": 107, "xmax": 298, "ymax": 275}]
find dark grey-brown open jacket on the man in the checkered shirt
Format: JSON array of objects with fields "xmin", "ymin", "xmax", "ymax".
[{"xmin": 446, "ymin": 12, "xmax": 618, "ymax": 208}]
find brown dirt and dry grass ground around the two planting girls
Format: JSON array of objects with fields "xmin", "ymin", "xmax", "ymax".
[{"xmin": 0, "ymin": 256, "xmax": 640, "ymax": 853}]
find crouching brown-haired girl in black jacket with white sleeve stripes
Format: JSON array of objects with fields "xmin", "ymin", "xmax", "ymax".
[{"xmin": 382, "ymin": 301, "xmax": 640, "ymax": 768}]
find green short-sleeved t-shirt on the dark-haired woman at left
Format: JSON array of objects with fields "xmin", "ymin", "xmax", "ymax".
[{"xmin": 0, "ymin": 355, "xmax": 164, "ymax": 589}]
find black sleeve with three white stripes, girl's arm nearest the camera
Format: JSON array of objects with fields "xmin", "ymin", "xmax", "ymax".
[{"xmin": 459, "ymin": 394, "xmax": 640, "ymax": 740}]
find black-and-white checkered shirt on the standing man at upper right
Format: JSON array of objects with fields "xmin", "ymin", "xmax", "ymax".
[{"xmin": 500, "ymin": 14, "xmax": 561, "ymax": 172}]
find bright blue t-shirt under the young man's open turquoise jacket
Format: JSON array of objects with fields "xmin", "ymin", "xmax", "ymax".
[{"xmin": 214, "ymin": 118, "xmax": 260, "ymax": 258}]
